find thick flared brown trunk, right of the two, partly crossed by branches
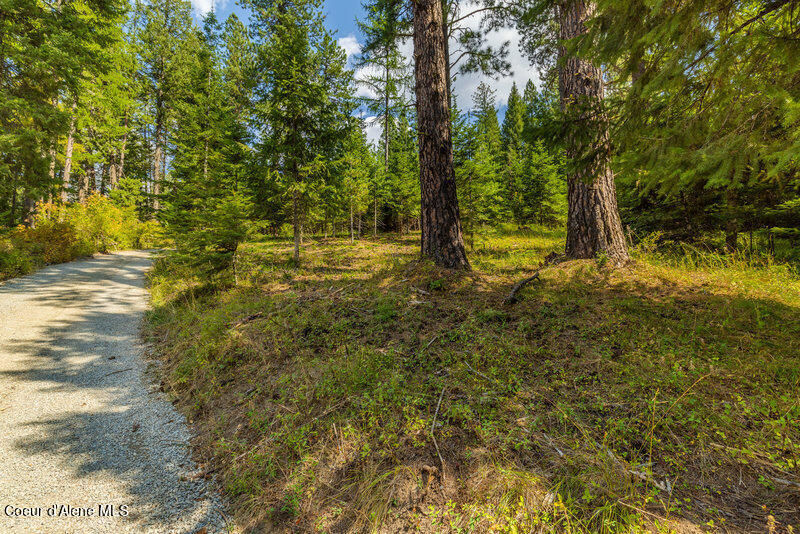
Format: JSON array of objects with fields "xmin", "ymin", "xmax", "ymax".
[{"xmin": 558, "ymin": 0, "xmax": 628, "ymax": 264}]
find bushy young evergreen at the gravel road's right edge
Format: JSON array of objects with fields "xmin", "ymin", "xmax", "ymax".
[{"xmin": 161, "ymin": 12, "xmax": 252, "ymax": 275}]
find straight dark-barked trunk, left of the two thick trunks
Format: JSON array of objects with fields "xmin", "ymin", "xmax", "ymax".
[{"xmin": 414, "ymin": 0, "xmax": 470, "ymax": 270}]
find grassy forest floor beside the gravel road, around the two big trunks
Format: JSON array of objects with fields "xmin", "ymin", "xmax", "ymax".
[{"xmin": 149, "ymin": 230, "xmax": 800, "ymax": 533}]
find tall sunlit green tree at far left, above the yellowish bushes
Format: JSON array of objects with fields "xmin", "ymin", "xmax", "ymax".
[{"xmin": 0, "ymin": 0, "xmax": 125, "ymax": 226}]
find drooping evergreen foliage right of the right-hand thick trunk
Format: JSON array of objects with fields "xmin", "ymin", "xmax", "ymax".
[{"xmin": 583, "ymin": 0, "xmax": 800, "ymax": 250}]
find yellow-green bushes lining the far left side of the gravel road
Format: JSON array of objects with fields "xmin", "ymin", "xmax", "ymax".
[{"xmin": 0, "ymin": 195, "xmax": 164, "ymax": 281}]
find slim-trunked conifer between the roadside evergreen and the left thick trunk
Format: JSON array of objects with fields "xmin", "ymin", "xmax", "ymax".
[{"xmin": 255, "ymin": 0, "xmax": 353, "ymax": 261}]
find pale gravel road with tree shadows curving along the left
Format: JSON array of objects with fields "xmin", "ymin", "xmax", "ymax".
[{"xmin": 0, "ymin": 252, "xmax": 226, "ymax": 533}]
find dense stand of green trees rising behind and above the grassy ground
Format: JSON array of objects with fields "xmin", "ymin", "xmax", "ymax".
[{"xmin": 0, "ymin": 0, "xmax": 800, "ymax": 267}]
